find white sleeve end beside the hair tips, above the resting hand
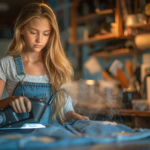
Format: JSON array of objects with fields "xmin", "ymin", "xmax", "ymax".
[{"xmin": 64, "ymin": 96, "xmax": 74, "ymax": 114}]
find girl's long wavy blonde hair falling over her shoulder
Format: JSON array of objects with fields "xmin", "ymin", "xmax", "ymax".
[{"xmin": 6, "ymin": 3, "xmax": 73, "ymax": 124}]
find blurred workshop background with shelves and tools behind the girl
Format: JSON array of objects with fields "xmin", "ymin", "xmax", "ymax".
[{"xmin": 0, "ymin": 0, "xmax": 150, "ymax": 127}]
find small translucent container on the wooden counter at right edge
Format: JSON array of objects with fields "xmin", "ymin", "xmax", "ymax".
[{"xmin": 132, "ymin": 100, "xmax": 149, "ymax": 111}]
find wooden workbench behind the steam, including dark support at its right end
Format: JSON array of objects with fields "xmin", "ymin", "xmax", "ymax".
[{"xmin": 74, "ymin": 101, "xmax": 150, "ymax": 128}]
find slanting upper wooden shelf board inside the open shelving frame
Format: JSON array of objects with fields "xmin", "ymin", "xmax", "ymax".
[{"xmin": 76, "ymin": 9, "xmax": 115, "ymax": 23}]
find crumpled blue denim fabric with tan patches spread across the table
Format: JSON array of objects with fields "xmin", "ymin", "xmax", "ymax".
[{"xmin": 0, "ymin": 120, "xmax": 150, "ymax": 150}]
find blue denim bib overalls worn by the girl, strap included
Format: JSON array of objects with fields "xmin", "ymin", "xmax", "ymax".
[{"xmin": 12, "ymin": 55, "xmax": 63, "ymax": 125}]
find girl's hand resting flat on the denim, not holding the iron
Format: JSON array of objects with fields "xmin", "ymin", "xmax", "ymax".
[{"xmin": 66, "ymin": 111, "xmax": 90, "ymax": 121}]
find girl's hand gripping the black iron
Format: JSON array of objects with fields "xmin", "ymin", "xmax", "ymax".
[{"xmin": 7, "ymin": 96, "xmax": 31, "ymax": 113}]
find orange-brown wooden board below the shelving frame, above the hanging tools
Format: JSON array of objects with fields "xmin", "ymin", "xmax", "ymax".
[{"xmin": 91, "ymin": 48, "xmax": 138, "ymax": 58}]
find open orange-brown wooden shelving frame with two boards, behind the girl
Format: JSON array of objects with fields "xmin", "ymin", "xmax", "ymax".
[{"xmin": 70, "ymin": 0, "xmax": 134, "ymax": 45}]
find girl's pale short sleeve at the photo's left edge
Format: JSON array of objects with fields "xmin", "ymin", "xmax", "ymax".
[{"xmin": 0, "ymin": 58, "xmax": 6, "ymax": 82}]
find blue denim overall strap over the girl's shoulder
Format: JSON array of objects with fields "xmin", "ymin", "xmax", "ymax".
[{"xmin": 14, "ymin": 55, "xmax": 25, "ymax": 76}]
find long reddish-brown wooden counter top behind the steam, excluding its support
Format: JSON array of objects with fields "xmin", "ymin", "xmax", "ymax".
[{"xmin": 75, "ymin": 102, "xmax": 150, "ymax": 117}]
